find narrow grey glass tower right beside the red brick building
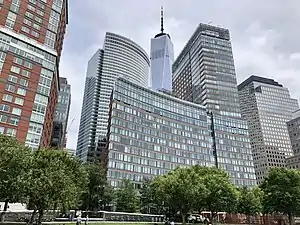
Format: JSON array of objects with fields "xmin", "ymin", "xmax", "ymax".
[{"xmin": 51, "ymin": 77, "xmax": 71, "ymax": 149}]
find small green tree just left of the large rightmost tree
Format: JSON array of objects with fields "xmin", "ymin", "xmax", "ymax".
[{"xmin": 237, "ymin": 187, "xmax": 262, "ymax": 223}]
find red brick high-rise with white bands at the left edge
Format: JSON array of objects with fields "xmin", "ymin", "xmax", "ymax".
[{"xmin": 0, "ymin": 0, "xmax": 68, "ymax": 149}]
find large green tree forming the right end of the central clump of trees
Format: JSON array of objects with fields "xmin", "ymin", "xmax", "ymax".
[{"xmin": 204, "ymin": 168, "xmax": 238, "ymax": 219}]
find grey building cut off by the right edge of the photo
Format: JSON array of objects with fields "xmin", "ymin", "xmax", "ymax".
[{"xmin": 287, "ymin": 109, "xmax": 300, "ymax": 155}]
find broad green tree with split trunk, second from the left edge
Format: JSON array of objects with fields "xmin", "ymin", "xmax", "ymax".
[{"xmin": 28, "ymin": 149, "xmax": 87, "ymax": 224}]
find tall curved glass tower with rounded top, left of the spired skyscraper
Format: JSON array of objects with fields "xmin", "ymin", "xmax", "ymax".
[{"xmin": 76, "ymin": 33, "xmax": 150, "ymax": 161}]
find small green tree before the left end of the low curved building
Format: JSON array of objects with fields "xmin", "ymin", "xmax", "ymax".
[{"xmin": 116, "ymin": 180, "xmax": 140, "ymax": 213}]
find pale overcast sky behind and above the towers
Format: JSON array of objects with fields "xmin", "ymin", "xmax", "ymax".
[{"xmin": 60, "ymin": 0, "xmax": 300, "ymax": 149}]
